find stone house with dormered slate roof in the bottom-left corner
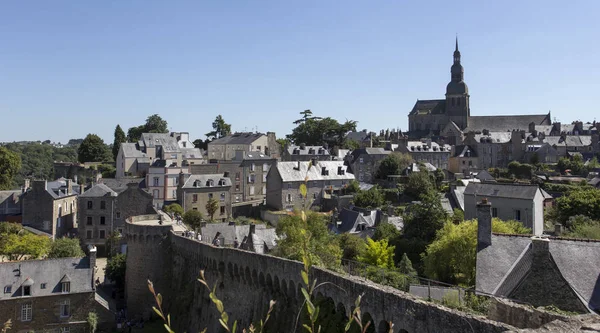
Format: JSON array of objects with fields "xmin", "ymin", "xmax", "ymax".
[{"xmin": 0, "ymin": 248, "xmax": 104, "ymax": 333}]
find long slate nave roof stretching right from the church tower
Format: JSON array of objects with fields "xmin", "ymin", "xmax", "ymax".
[{"xmin": 464, "ymin": 114, "xmax": 550, "ymax": 133}]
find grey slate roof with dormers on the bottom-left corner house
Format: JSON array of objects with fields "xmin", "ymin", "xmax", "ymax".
[{"xmin": 0, "ymin": 257, "xmax": 93, "ymax": 300}]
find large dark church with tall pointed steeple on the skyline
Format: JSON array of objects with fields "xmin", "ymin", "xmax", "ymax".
[{"xmin": 408, "ymin": 38, "xmax": 552, "ymax": 145}]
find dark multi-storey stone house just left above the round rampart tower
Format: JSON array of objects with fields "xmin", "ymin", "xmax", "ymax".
[{"xmin": 78, "ymin": 182, "xmax": 156, "ymax": 256}]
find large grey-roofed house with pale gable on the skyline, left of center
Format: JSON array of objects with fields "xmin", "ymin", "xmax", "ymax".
[{"xmin": 207, "ymin": 132, "xmax": 280, "ymax": 161}]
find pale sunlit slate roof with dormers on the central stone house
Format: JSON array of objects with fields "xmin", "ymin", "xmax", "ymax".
[{"xmin": 275, "ymin": 161, "xmax": 354, "ymax": 182}]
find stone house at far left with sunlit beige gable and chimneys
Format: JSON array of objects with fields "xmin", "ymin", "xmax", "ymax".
[{"xmin": 21, "ymin": 179, "xmax": 79, "ymax": 238}]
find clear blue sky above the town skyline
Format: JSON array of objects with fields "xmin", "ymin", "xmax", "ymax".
[{"xmin": 0, "ymin": 0, "xmax": 600, "ymax": 143}]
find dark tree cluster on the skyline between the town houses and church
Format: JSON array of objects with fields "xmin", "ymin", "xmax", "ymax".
[{"xmin": 286, "ymin": 110, "xmax": 356, "ymax": 147}]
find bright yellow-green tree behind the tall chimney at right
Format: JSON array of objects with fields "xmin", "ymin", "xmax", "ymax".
[{"xmin": 423, "ymin": 219, "xmax": 530, "ymax": 286}]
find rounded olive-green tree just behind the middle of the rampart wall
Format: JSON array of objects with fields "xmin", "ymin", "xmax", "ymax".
[{"xmin": 275, "ymin": 211, "xmax": 342, "ymax": 269}]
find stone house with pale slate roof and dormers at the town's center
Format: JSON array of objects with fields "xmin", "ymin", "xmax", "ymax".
[{"xmin": 267, "ymin": 160, "xmax": 354, "ymax": 210}]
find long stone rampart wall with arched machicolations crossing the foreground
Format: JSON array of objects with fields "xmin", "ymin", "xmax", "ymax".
[{"xmin": 127, "ymin": 219, "xmax": 514, "ymax": 332}]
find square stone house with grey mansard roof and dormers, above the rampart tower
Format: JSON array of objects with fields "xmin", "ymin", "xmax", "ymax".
[{"xmin": 177, "ymin": 173, "xmax": 232, "ymax": 222}]
